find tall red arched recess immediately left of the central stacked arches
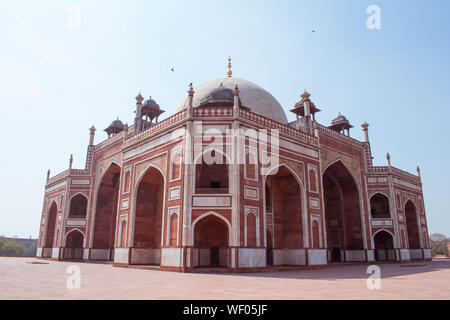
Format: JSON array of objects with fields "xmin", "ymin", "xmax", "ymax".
[{"xmin": 131, "ymin": 167, "xmax": 164, "ymax": 265}]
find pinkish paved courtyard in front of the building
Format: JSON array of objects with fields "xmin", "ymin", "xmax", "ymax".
[{"xmin": 0, "ymin": 257, "xmax": 450, "ymax": 300}]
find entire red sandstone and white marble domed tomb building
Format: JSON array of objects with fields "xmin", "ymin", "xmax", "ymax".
[{"xmin": 37, "ymin": 71, "xmax": 431, "ymax": 272}]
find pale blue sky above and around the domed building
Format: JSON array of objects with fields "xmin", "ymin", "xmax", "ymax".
[{"xmin": 0, "ymin": 0, "xmax": 450, "ymax": 237}]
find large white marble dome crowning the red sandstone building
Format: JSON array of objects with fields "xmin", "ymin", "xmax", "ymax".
[{"xmin": 177, "ymin": 77, "xmax": 287, "ymax": 124}]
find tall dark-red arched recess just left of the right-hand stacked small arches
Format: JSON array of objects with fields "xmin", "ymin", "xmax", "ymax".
[{"xmin": 323, "ymin": 161, "xmax": 365, "ymax": 262}]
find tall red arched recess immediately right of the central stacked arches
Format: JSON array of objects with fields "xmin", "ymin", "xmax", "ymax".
[{"xmin": 265, "ymin": 165, "xmax": 304, "ymax": 265}]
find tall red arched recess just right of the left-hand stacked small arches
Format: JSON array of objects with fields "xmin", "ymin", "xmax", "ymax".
[{"xmin": 91, "ymin": 163, "xmax": 120, "ymax": 260}]
